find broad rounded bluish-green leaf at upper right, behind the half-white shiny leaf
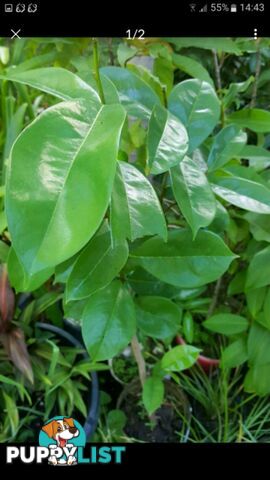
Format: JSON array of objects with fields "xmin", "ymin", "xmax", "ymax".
[{"xmin": 168, "ymin": 79, "xmax": 220, "ymax": 152}]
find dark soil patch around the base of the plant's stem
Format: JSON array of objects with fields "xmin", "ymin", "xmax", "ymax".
[{"xmin": 117, "ymin": 379, "xmax": 189, "ymax": 443}]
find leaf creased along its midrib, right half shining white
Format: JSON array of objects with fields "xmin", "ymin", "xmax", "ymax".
[{"xmin": 147, "ymin": 105, "xmax": 188, "ymax": 174}]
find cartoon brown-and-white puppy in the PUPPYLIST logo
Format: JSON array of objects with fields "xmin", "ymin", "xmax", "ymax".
[{"xmin": 42, "ymin": 418, "xmax": 80, "ymax": 465}]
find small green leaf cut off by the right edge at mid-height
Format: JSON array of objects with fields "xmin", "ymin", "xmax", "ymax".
[{"xmin": 246, "ymin": 246, "xmax": 270, "ymax": 289}]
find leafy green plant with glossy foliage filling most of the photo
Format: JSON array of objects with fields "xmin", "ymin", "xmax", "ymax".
[{"xmin": 0, "ymin": 39, "xmax": 270, "ymax": 428}]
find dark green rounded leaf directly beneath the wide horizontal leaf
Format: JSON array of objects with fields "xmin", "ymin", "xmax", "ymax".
[{"xmin": 136, "ymin": 296, "xmax": 182, "ymax": 339}]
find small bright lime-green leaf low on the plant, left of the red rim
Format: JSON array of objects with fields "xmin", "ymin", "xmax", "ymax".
[{"xmin": 161, "ymin": 345, "xmax": 200, "ymax": 372}]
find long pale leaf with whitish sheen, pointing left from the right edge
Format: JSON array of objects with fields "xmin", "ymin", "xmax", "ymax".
[{"xmin": 211, "ymin": 172, "xmax": 270, "ymax": 214}]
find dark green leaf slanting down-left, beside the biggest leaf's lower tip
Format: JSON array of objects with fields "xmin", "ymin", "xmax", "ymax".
[{"xmin": 66, "ymin": 232, "xmax": 128, "ymax": 301}]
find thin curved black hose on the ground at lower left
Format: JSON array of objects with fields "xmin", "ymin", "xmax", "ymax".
[{"xmin": 35, "ymin": 322, "xmax": 99, "ymax": 440}]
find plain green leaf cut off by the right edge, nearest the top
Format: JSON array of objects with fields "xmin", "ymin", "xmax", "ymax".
[{"xmin": 228, "ymin": 108, "xmax": 270, "ymax": 133}]
